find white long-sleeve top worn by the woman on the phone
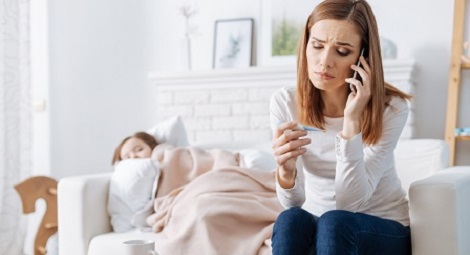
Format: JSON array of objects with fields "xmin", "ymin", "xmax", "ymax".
[{"xmin": 270, "ymin": 87, "xmax": 409, "ymax": 226}]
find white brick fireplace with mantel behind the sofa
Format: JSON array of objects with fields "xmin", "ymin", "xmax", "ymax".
[{"xmin": 149, "ymin": 60, "xmax": 413, "ymax": 144}]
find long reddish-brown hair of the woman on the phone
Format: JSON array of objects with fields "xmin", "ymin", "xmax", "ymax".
[{"xmin": 297, "ymin": 0, "xmax": 411, "ymax": 145}]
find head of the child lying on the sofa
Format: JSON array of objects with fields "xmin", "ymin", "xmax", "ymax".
[{"xmin": 112, "ymin": 132, "xmax": 158, "ymax": 165}]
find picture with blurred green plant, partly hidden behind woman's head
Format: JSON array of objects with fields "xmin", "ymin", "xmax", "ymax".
[{"xmin": 257, "ymin": 0, "xmax": 322, "ymax": 66}]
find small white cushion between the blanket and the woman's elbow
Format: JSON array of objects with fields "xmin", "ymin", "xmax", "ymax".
[{"xmin": 238, "ymin": 149, "xmax": 277, "ymax": 171}]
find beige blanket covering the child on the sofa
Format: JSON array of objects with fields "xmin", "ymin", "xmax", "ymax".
[{"xmin": 147, "ymin": 144, "xmax": 282, "ymax": 255}]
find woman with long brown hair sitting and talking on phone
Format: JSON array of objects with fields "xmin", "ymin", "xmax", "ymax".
[{"xmin": 270, "ymin": 0, "xmax": 411, "ymax": 255}]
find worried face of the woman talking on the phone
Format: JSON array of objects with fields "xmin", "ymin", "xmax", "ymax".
[{"xmin": 306, "ymin": 19, "xmax": 361, "ymax": 91}]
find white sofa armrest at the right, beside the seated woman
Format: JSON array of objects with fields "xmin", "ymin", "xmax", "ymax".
[{"xmin": 409, "ymin": 167, "xmax": 470, "ymax": 255}]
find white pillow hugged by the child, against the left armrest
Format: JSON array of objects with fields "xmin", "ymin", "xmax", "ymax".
[{"xmin": 108, "ymin": 158, "xmax": 160, "ymax": 232}]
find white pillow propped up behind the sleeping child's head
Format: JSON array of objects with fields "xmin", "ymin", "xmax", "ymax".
[{"xmin": 147, "ymin": 116, "xmax": 189, "ymax": 147}]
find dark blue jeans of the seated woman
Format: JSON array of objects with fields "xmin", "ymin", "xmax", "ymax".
[{"xmin": 272, "ymin": 207, "xmax": 411, "ymax": 255}]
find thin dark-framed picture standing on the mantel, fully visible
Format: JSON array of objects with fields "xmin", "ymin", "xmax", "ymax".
[{"xmin": 212, "ymin": 18, "xmax": 254, "ymax": 69}]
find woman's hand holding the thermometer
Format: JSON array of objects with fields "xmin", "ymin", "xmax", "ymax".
[{"xmin": 273, "ymin": 122, "xmax": 311, "ymax": 189}]
